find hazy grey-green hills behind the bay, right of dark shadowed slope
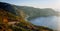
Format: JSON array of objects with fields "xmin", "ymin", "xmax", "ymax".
[{"xmin": 15, "ymin": 6, "xmax": 58, "ymax": 20}]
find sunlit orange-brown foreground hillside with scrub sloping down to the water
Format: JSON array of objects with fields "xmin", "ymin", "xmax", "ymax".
[{"xmin": 0, "ymin": 9, "xmax": 53, "ymax": 31}]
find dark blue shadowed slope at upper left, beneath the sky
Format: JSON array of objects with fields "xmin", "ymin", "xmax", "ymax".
[{"xmin": 0, "ymin": 2, "xmax": 16, "ymax": 15}]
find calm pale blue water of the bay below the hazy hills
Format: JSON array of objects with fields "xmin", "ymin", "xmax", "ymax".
[{"xmin": 30, "ymin": 16, "xmax": 60, "ymax": 29}]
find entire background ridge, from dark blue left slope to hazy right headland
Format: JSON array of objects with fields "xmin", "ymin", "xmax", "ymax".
[{"xmin": 0, "ymin": 3, "xmax": 59, "ymax": 20}]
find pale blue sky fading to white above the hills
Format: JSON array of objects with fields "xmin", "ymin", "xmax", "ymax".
[{"xmin": 0, "ymin": 0, "xmax": 60, "ymax": 9}]
